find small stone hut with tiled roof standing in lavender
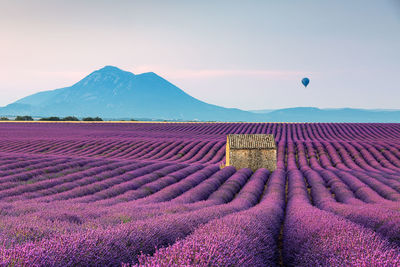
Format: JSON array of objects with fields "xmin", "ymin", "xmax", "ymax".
[{"xmin": 226, "ymin": 134, "xmax": 276, "ymax": 171}]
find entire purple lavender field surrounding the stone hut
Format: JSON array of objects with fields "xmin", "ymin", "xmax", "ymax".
[{"xmin": 0, "ymin": 122, "xmax": 400, "ymax": 266}]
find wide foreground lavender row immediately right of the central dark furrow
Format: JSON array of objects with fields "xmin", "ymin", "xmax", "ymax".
[{"xmin": 283, "ymin": 171, "xmax": 400, "ymax": 266}]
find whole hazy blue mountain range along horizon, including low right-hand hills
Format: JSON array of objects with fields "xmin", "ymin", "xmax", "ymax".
[{"xmin": 0, "ymin": 66, "xmax": 400, "ymax": 122}]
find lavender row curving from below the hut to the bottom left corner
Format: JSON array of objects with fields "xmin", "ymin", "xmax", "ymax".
[{"xmin": 0, "ymin": 169, "xmax": 268, "ymax": 266}]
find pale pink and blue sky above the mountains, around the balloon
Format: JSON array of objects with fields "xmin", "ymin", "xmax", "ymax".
[{"xmin": 0, "ymin": 0, "xmax": 400, "ymax": 110}]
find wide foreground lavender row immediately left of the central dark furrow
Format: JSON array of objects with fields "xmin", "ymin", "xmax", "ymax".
[{"xmin": 138, "ymin": 169, "xmax": 285, "ymax": 266}]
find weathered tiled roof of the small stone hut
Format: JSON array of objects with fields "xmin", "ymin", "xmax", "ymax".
[{"xmin": 228, "ymin": 134, "xmax": 276, "ymax": 149}]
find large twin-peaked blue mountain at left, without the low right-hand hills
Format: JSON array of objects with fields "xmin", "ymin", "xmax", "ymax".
[{"xmin": 0, "ymin": 66, "xmax": 260, "ymax": 121}]
